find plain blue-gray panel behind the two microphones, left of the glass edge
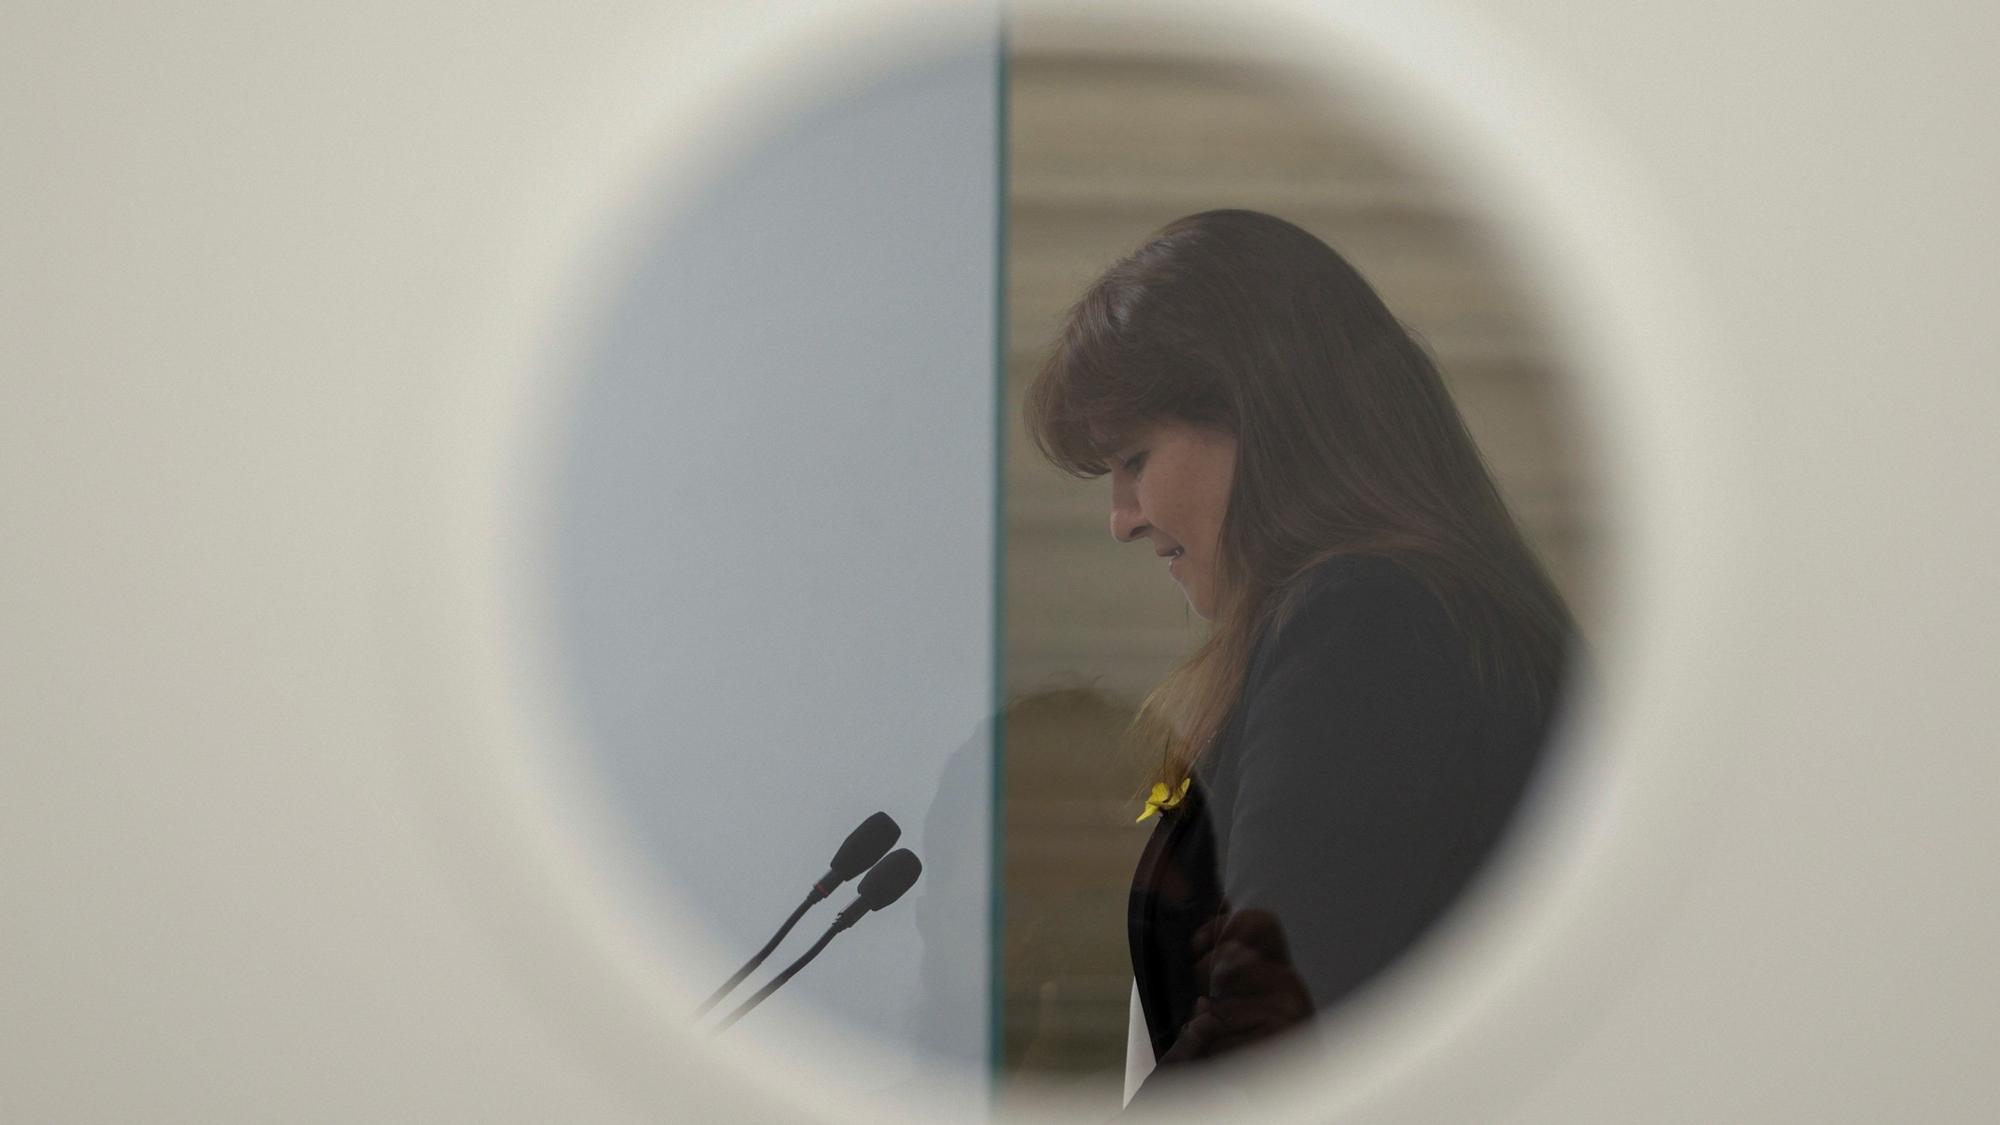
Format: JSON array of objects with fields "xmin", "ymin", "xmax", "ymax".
[{"xmin": 556, "ymin": 42, "xmax": 1000, "ymax": 1097}]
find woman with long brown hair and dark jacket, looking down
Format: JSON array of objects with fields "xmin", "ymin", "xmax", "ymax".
[{"xmin": 1026, "ymin": 210, "xmax": 1572, "ymax": 1087}]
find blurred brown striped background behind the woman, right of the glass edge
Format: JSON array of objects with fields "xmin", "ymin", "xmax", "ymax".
[{"xmin": 1002, "ymin": 46, "xmax": 1596, "ymax": 1109}]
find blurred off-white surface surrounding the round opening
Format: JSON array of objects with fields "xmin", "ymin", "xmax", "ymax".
[{"xmin": 0, "ymin": 0, "xmax": 2000, "ymax": 1123}]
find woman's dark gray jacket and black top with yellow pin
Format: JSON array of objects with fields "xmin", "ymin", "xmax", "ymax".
[{"xmin": 1128, "ymin": 556, "xmax": 1548, "ymax": 1064}]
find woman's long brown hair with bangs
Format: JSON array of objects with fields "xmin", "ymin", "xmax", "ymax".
[{"xmin": 1026, "ymin": 210, "xmax": 1574, "ymax": 783}]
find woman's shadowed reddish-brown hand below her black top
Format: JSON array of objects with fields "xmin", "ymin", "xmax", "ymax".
[{"xmin": 1160, "ymin": 903, "xmax": 1312, "ymax": 1065}]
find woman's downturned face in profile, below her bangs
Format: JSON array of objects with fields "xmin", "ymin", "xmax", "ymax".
[{"xmin": 1110, "ymin": 418, "xmax": 1236, "ymax": 619}]
